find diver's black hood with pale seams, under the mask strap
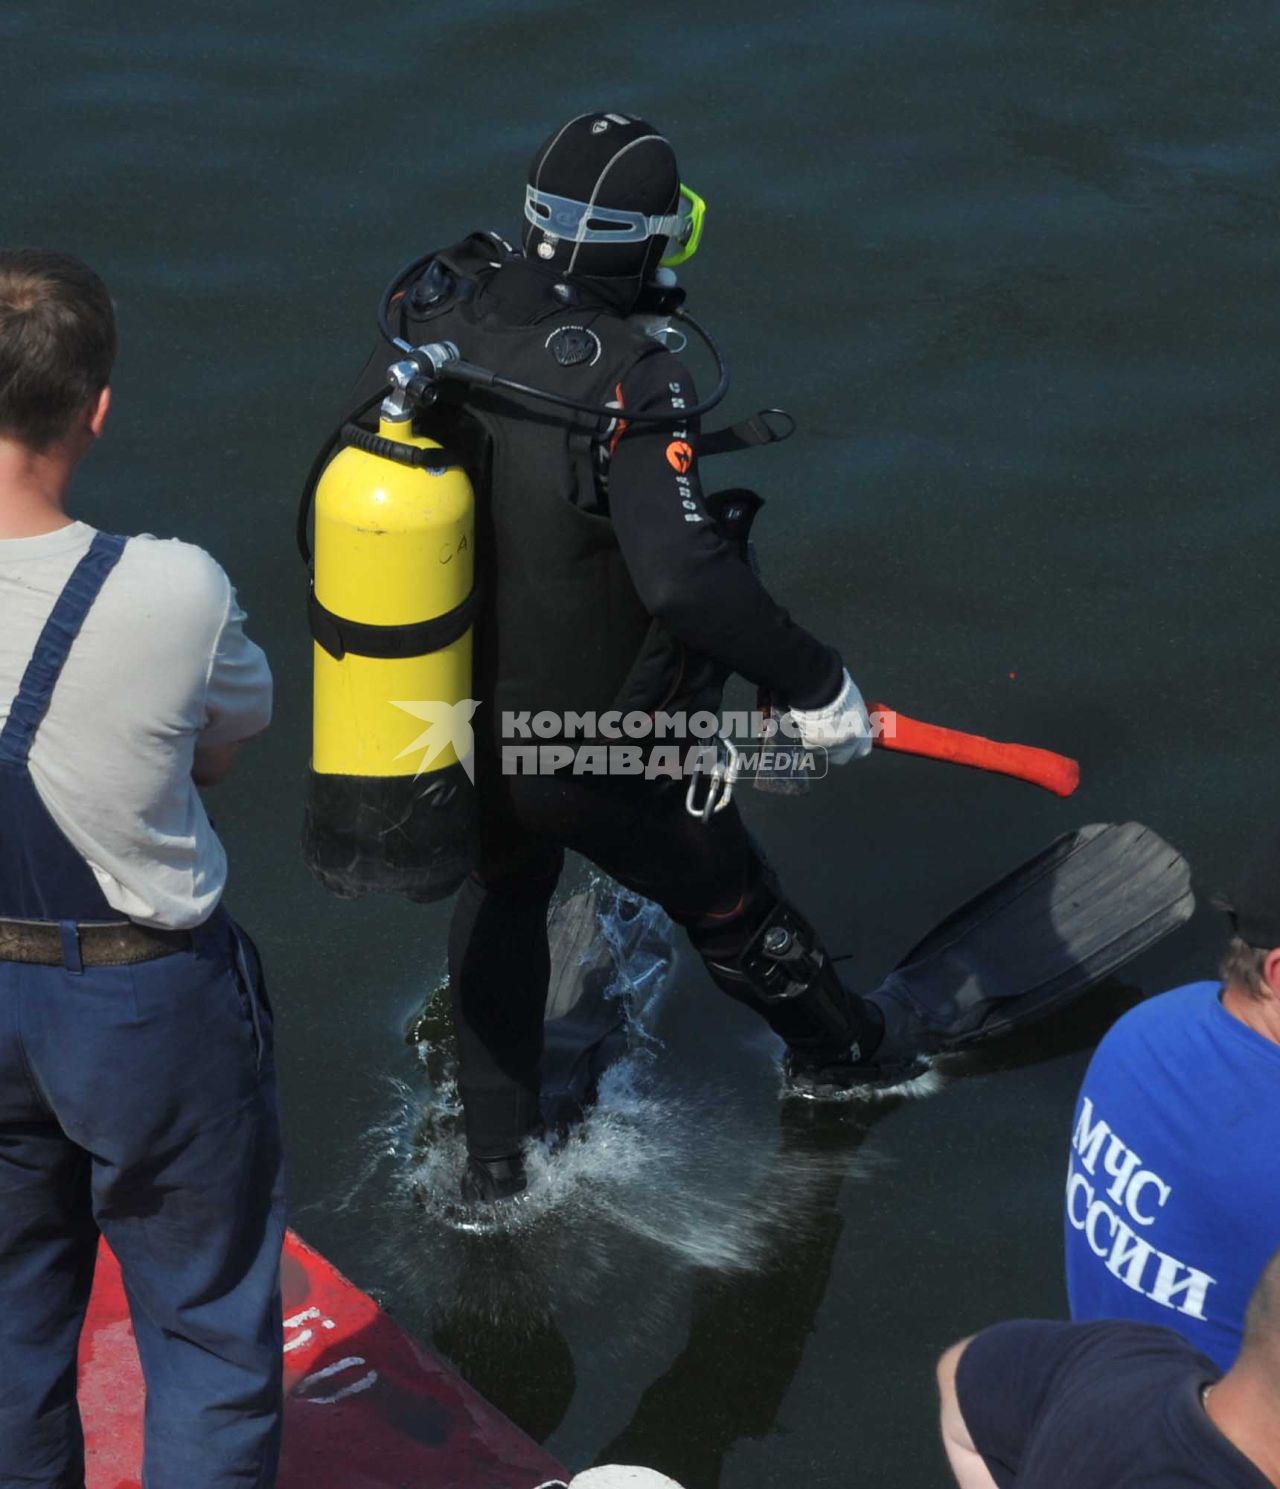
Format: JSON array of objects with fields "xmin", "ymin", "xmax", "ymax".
[{"xmin": 522, "ymin": 113, "xmax": 680, "ymax": 286}]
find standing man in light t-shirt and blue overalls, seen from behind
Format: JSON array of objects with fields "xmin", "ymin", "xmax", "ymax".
[{"xmin": 0, "ymin": 250, "xmax": 284, "ymax": 1489}]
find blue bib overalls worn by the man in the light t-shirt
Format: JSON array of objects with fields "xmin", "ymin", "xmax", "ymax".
[{"xmin": 0, "ymin": 533, "xmax": 284, "ymax": 1489}]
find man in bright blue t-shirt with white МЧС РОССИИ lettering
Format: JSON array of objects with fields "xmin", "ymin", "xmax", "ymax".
[{"xmin": 1066, "ymin": 837, "xmax": 1280, "ymax": 1370}]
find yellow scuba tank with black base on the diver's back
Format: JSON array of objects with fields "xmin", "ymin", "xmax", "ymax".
[{"xmin": 304, "ymin": 390, "xmax": 475, "ymax": 901}]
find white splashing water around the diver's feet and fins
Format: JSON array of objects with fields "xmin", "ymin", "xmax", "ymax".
[{"xmin": 345, "ymin": 879, "xmax": 938, "ymax": 1339}]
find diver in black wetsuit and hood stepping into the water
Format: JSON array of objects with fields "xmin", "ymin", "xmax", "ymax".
[{"xmin": 320, "ymin": 112, "xmax": 1190, "ymax": 1202}]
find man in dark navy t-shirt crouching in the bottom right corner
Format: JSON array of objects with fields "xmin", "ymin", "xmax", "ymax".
[{"xmin": 938, "ymin": 1252, "xmax": 1280, "ymax": 1489}]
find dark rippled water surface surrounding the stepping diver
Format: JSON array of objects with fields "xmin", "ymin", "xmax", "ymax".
[{"xmin": 0, "ymin": 0, "xmax": 1280, "ymax": 1489}]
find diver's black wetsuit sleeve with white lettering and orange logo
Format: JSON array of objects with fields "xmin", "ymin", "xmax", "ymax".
[{"xmin": 609, "ymin": 353, "xmax": 844, "ymax": 709}]
